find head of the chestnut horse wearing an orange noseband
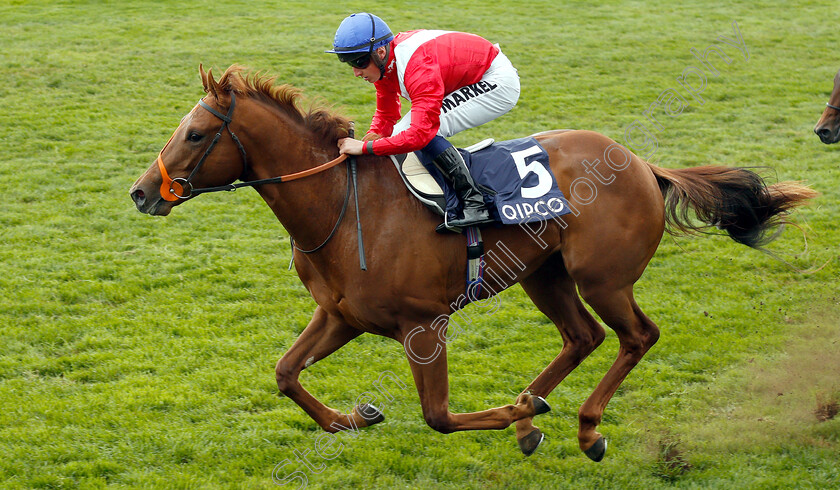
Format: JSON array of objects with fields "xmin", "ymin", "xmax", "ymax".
[{"xmin": 129, "ymin": 66, "xmax": 247, "ymax": 216}]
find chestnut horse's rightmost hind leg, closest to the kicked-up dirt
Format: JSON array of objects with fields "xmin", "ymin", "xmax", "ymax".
[{"xmin": 578, "ymin": 284, "xmax": 659, "ymax": 461}]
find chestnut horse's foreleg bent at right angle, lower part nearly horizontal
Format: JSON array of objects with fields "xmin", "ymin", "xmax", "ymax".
[{"xmin": 401, "ymin": 323, "xmax": 548, "ymax": 434}]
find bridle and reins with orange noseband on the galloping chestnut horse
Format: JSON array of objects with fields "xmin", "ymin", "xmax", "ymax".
[{"xmin": 157, "ymin": 91, "xmax": 358, "ymax": 254}]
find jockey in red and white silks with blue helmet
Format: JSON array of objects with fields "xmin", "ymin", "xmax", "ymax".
[{"xmin": 327, "ymin": 13, "xmax": 519, "ymax": 231}]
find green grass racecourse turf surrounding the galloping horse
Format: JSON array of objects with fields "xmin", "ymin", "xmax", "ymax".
[{"xmin": 0, "ymin": 0, "xmax": 840, "ymax": 489}]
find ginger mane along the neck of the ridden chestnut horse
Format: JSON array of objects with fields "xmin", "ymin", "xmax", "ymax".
[{"xmin": 210, "ymin": 65, "xmax": 350, "ymax": 142}]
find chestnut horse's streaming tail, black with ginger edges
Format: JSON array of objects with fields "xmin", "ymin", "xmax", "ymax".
[{"xmin": 648, "ymin": 163, "xmax": 818, "ymax": 248}]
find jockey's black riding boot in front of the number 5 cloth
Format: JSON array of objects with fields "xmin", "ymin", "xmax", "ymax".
[{"xmin": 434, "ymin": 146, "xmax": 493, "ymax": 231}]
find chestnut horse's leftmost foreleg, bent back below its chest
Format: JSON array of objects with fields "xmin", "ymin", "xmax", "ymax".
[{"xmin": 275, "ymin": 306, "xmax": 383, "ymax": 432}]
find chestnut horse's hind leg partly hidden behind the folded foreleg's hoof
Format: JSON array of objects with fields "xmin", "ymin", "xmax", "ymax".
[{"xmin": 516, "ymin": 254, "xmax": 604, "ymax": 455}]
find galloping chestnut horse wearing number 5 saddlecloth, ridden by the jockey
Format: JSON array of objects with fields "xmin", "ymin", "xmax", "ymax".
[{"xmin": 130, "ymin": 66, "xmax": 815, "ymax": 461}]
